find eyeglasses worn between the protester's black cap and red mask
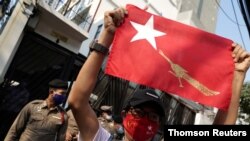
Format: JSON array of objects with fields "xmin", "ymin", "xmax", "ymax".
[{"xmin": 129, "ymin": 107, "xmax": 160, "ymax": 122}]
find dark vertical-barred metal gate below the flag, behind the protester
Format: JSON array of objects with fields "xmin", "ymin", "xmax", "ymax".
[{"xmin": 93, "ymin": 68, "xmax": 196, "ymax": 125}]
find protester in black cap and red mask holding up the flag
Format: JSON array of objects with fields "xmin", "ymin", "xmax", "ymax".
[{"xmin": 68, "ymin": 8, "xmax": 250, "ymax": 141}]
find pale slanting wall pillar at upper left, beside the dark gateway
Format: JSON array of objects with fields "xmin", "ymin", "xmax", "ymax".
[{"xmin": 0, "ymin": 0, "xmax": 28, "ymax": 82}]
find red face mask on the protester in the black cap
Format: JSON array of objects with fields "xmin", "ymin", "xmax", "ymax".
[{"xmin": 123, "ymin": 114, "xmax": 159, "ymax": 141}]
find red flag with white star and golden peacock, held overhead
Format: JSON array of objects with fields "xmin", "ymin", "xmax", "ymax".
[{"xmin": 106, "ymin": 5, "xmax": 234, "ymax": 109}]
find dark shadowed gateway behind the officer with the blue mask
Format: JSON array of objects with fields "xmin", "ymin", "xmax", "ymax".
[{"xmin": 0, "ymin": 32, "xmax": 86, "ymax": 140}]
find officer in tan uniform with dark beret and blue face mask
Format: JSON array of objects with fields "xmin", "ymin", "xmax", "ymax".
[{"xmin": 4, "ymin": 79, "xmax": 68, "ymax": 141}]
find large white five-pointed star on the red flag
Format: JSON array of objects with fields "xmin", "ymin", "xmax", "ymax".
[{"xmin": 130, "ymin": 16, "xmax": 166, "ymax": 50}]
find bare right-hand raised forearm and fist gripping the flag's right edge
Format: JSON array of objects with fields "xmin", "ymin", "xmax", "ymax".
[{"xmin": 213, "ymin": 43, "xmax": 250, "ymax": 124}]
